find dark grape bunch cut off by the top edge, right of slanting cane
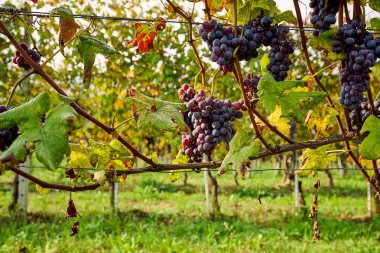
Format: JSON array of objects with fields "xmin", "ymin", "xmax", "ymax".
[{"xmin": 309, "ymin": 0, "xmax": 340, "ymax": 37}]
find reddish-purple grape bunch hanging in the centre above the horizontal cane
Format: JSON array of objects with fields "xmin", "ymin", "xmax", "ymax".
[{"xmin": 179, "ymin": 84, "xmax": 243, "ymax": 162}]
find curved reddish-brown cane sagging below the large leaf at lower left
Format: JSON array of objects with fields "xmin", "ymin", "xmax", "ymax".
[{"xmin": 9, "ymin": 167, "xmax": 100, "ymax": 192}]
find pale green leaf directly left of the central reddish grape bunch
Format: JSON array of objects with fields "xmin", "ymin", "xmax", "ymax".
[{"xmin": 127, "ymin": 91, "xmax": 189, "ymax": 136}]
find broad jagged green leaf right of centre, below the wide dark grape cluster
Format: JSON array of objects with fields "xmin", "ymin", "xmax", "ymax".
[{"xmin": 258, "ymin": 74, "xmax": 326, "ymax": 122}]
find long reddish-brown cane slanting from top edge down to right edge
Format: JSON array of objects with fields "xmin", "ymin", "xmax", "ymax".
[{"xmin": 293, "ymin": 0, "xmax": 379, "ymax": 193}]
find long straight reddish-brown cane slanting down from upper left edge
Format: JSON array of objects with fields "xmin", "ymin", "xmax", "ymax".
[{"xmin": 0, "ymin": 20, "xmax": 157, "ymax": 167}]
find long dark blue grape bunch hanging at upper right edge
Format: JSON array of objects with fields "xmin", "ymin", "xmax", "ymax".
[{"xmin": 332, "ymin": 20, "xmax": 380, "ymax": 110}]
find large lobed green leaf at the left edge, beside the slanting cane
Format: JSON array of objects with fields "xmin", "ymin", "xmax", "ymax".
[{"xmin": 0, "ymin": 100, "xmax": 75, "ymax": 169}]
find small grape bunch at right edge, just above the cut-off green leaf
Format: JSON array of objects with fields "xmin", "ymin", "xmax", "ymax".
[{"xmin": 350, "ymin": 97, "xmax": 380, "ymax": 131}]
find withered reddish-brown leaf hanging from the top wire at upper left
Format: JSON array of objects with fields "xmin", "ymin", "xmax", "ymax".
[{"xmin": 50, "ymin": 7, "xmax": 80, "ymax": 55}]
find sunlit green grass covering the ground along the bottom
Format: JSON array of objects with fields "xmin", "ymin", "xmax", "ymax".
[{"xmin": 0, "ymin": 168, "xmax": 380, "ymax": 253}]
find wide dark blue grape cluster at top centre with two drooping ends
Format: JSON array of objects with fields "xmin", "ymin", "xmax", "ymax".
[{"xmin": 199, "ymin": 15, "xmax": 294, "ymax": 81}]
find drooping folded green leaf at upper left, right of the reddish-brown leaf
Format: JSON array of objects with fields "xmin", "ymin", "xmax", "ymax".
[{"xmin": 77, "ymin": 35, "xmax": 121, "ymax": 88}]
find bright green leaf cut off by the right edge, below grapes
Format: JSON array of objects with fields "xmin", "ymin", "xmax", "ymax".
[{"xmin": 359, "ymin": 115, "xmax": 380, "ymax": 160}]
